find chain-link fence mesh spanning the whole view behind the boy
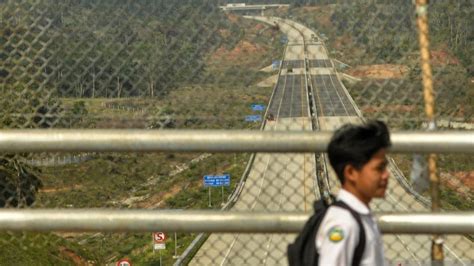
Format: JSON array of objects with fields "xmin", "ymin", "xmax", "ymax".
[{"xmin": 0, "ymin": 0, "xmax": 474, "ymax": 265}]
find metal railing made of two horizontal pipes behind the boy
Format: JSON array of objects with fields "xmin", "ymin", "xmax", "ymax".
[{"xmin": 0, "ymin": 130, "xmax": 474, "ymax": 234}]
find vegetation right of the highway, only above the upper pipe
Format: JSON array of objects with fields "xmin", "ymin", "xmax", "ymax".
[{"xmin": 292, "ymin": 1, "xmax": 474, "ymax": 126}]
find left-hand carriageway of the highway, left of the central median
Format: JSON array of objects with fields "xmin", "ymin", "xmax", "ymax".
[{"xmin": 190, "ymin": 15, "xmax": 319, "ymax": 265}]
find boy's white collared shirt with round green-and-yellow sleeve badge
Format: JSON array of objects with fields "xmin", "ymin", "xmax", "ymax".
[{"xmin": 316, "ymin": 189, "xmax": 387, "ymax": 266}]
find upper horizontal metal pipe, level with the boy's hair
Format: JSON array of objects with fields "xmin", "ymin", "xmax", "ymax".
[{"xmin": 0, "ymin": 129, "xmax": 474, "ymax": 153}]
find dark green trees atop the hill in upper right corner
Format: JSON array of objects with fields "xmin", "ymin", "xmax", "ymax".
[{"xmin": 331, "ymin": 1, "xmax": 474, "ymax": 72}]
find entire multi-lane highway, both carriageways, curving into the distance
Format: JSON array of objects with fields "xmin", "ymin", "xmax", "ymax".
[{"xmin": 191, "ymin": 17, "xmax": 474, "ymax": 265}]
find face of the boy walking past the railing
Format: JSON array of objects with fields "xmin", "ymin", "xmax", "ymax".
[{"xmin": 355, "ymin": 149, "xmax": 389, "ymax": 199}]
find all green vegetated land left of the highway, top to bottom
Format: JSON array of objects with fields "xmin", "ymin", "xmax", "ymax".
[{"xmin": 0, "ymin": 0, "xmax": 283, "ymax": 265}]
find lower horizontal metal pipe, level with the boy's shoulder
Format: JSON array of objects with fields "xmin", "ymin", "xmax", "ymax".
[{"xmin": 0, "ymin": 209, "xmax": 474, "ymax": 234}]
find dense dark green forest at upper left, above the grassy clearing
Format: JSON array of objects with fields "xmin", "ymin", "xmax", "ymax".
[{"xmin": 0, "ymin": 1, "xmax": 227, "ymax": 97}]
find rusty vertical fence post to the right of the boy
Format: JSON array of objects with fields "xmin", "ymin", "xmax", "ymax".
[{"xmin": 416, "ymin": 0, "xmax": 444, "ymax": 265}]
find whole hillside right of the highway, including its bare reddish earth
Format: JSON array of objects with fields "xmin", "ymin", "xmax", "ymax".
[{"xmin": 286, "ymin": 1, "xmax": 474, "ymax": 210}]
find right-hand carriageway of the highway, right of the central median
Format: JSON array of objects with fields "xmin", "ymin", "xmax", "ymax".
[{"xmin": 287, "ymin": 18, "xmax": 474, "ymax": 265}]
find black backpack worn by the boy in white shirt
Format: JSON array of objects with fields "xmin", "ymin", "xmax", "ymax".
[{"xmin": 288, "ymin": 200, "xmax": 365, "ymax": 266}]
